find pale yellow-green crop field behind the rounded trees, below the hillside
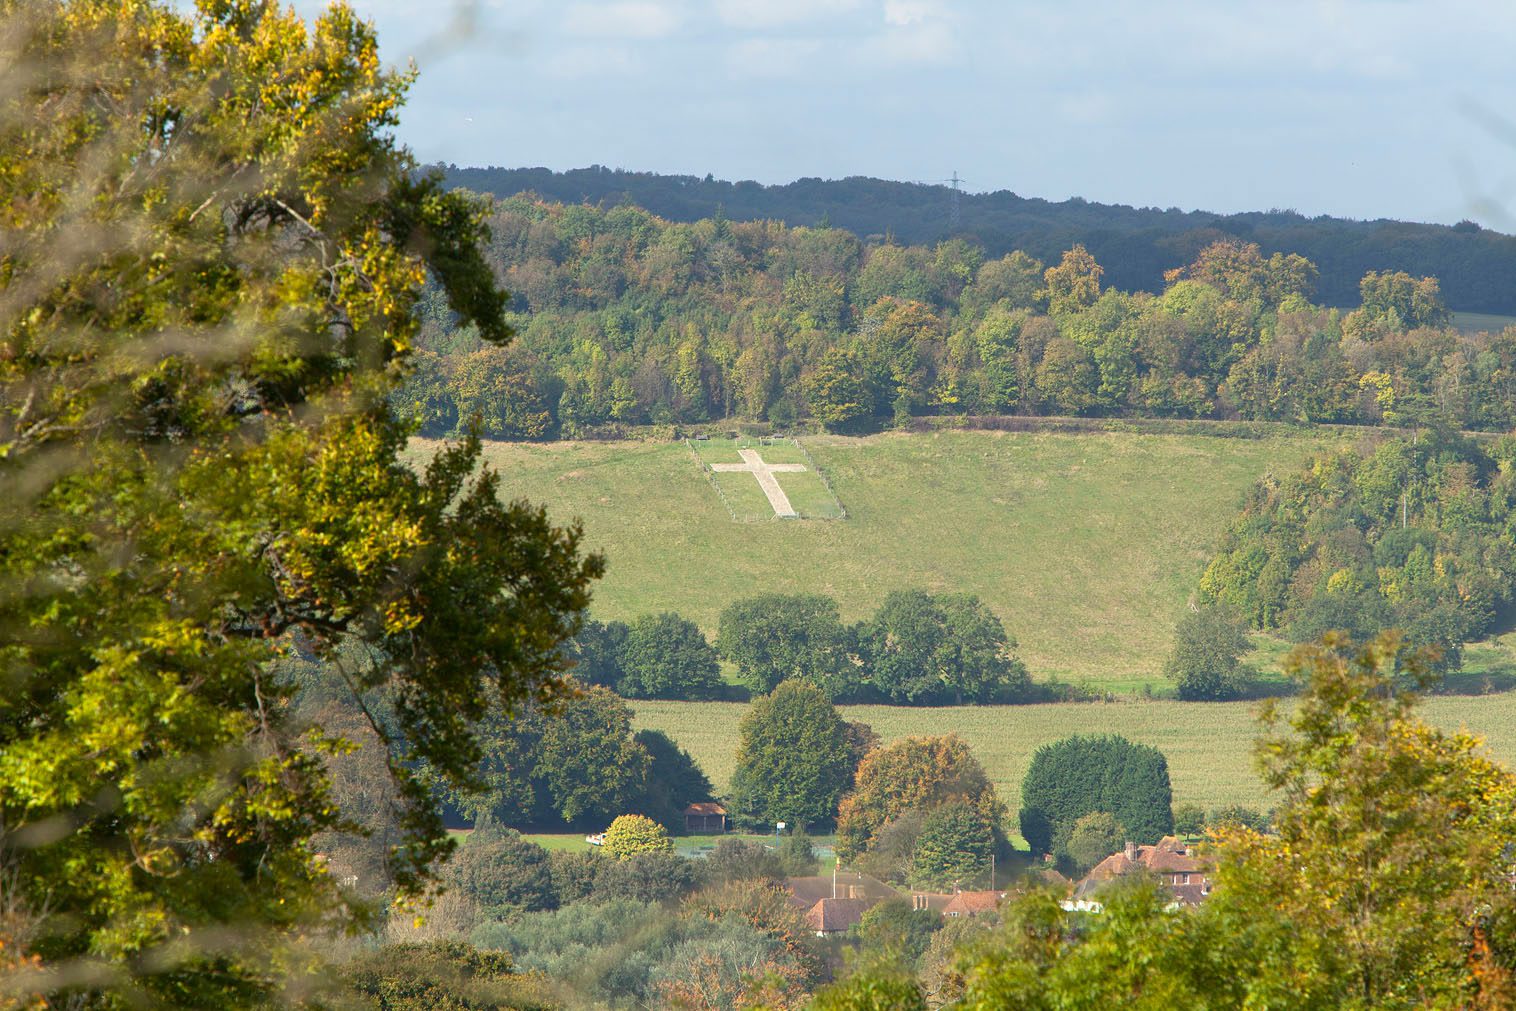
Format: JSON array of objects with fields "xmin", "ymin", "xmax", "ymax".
[{"xmin": 632, "ymin": 691, "xmax": 1516, "ymax": 830}]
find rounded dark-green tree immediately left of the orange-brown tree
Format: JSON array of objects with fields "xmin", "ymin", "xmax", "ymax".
[{"xmin": 732, "ymin": 681, "xmax": 852, "ymax": 828}]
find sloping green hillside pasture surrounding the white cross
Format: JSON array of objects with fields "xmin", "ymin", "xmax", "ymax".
[{"xmin": 430, "ymin": 429, "xmax": 1342, "ymax": 690}]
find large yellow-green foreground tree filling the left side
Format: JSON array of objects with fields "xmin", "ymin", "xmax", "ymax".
[{"xmin": 0, "ymin": 0, "xmax": 600, "ymax": 1008}]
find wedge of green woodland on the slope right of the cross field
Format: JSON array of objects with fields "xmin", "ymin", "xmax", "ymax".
[{"xmin": 1167, "ymin": 427, "xmax": 1516, "ymax": 699}]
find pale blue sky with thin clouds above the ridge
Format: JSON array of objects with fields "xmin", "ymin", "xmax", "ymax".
[{"xmin": 296, "ymin": 0, "xmax": 1516, "ymax": 230}]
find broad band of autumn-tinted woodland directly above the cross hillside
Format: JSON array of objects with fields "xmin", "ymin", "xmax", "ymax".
[{"xmin": 397, "ymin": 196, "xmax": 1516, "ymax": 440}]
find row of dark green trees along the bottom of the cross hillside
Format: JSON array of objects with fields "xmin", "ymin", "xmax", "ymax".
[{"xmin": 564, "ymin": 590, "xmax": 1032, "ymax": 705}]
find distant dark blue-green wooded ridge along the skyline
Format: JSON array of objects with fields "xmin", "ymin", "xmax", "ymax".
[{"xmin": 444, "ymin": 165, "xmax": 1516, "ymax": 312}]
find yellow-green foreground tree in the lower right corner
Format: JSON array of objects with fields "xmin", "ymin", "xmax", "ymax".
[{"xmin": 1216, "ymin": 635, "xmax": 1516, "ymax": 1008}]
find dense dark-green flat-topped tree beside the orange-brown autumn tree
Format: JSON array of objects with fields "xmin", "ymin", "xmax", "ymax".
[{"xmin": 1020, "ymin": 734, "xmax": 1173, "ymax": 853}]
